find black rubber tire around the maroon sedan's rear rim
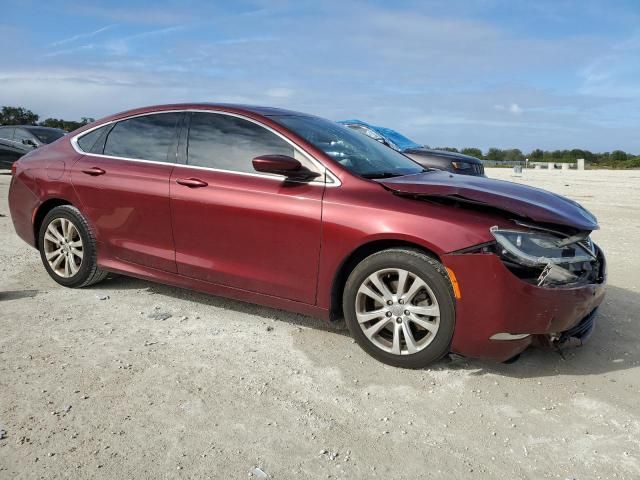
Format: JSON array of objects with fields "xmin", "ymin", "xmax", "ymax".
[{"xmin": 38, "ymin": 205, "xmax": 108, "ymax": 288}]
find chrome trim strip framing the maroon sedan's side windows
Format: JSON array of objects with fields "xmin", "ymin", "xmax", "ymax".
[{"xmin": 70, "ymin": 108, "xmax": 342, "ymax": 187}]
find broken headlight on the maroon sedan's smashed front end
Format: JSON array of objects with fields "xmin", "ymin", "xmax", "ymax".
[{"xmin": 491, "ymin": 227, "xmax": 597, "ymax": 286}]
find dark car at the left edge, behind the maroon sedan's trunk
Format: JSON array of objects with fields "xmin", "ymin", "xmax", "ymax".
[{"xmin": 0, "ymin": 125, "xmax": 66, "ymax": 168}]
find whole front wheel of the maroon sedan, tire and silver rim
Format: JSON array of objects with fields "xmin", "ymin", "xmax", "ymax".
[{"xmin": 343, "ymin": 249, "xmax": 455, "ymax": 368}]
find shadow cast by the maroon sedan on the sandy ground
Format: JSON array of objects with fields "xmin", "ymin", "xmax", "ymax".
[{"xmin": 90, "ymin": 275, "xmax": 640, "ymax": 378}]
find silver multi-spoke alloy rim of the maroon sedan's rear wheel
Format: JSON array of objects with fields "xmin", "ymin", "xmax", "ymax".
[{"xmin": 43, "ymin": 217, "xmax": 83, "ymax": 278}]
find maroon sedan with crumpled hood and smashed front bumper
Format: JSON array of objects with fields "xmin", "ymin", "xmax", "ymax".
[{"xmin": 9, "ymin": 104, "xmax": 605, "ymax": 368}]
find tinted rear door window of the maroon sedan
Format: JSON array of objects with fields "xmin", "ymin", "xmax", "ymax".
[{"xmin": 104, "ymin": 112, "xmax": 183, "ymax": 163}]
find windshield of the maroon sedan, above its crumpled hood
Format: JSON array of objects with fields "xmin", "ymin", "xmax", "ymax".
[{"xmin": 273, "ymin": 116, "xmax": 424, "ymax": 178}]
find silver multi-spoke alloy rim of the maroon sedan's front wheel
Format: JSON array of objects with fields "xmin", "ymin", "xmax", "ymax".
[{"xmin": 356, "ymin": 268, "xmax": 440, "ymax": 355}]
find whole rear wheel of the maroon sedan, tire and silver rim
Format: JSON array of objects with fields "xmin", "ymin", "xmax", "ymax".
[{"xmin": 38, "ymin": 205, "xmax": 107, "ymax": 288}]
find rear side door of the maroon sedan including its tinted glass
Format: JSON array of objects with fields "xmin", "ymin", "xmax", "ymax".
[{"xmin": 71, "ymin": 112, "xmax": 184, "ymax": 272}]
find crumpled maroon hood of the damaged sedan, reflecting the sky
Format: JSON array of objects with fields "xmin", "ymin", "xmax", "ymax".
[{"xmin": 376, "ymin": 170, "xmax": 599, "ymax": 231}]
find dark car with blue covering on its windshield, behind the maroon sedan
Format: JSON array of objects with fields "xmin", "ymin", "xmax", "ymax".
[{"xmin": 338, "ymin": 120, "xmax": 485, "ymax": 176}]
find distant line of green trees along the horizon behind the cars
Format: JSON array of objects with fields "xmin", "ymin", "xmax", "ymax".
[{"xmin": 0, "ymin": 107, "xmax": 640, "ymax": 168}]
